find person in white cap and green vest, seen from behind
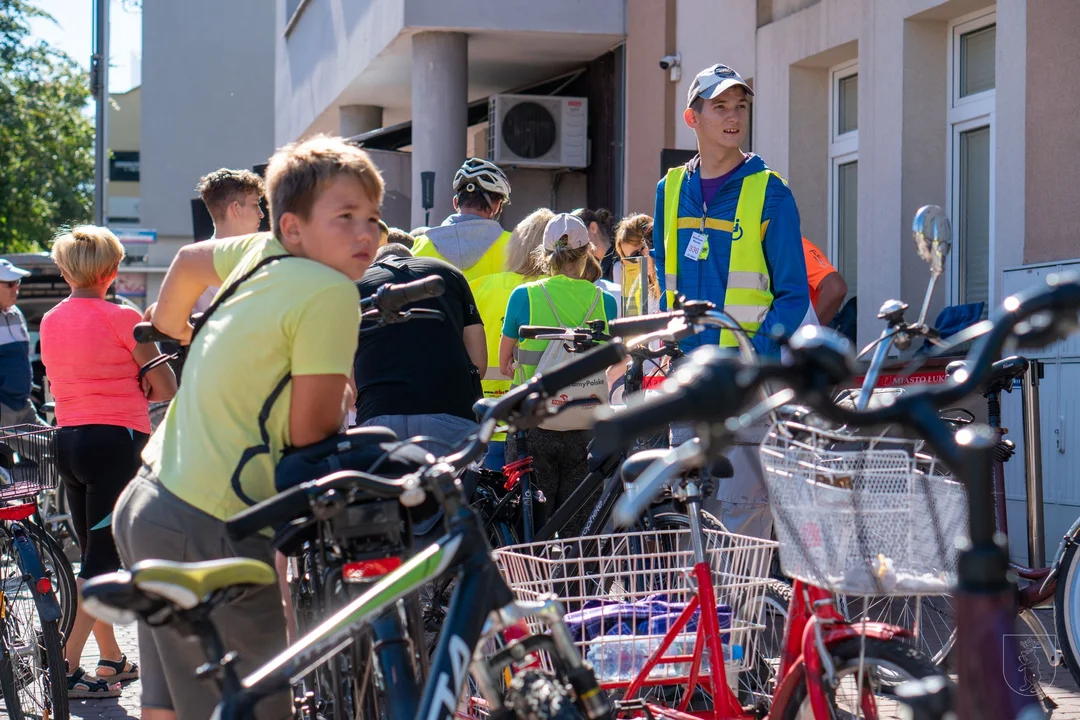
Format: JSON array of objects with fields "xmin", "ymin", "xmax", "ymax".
[{"xmin": 499, "ymin": 214, "xmax": 618, "ymax": 534}]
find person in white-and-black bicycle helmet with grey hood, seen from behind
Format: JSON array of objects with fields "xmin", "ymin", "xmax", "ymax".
[{"xmin": 413, "ymin": 158, "xmax": 510, "ymax": 285}]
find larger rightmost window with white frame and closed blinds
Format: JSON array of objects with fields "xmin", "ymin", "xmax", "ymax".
[{"xmin": 948, "ymin": 13, "xmax": 997, "ymax": 314}]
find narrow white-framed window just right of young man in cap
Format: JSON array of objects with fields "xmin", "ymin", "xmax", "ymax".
[{"xmin": 828, "ymin": 63, "xmax": 859, "ymax": 295}]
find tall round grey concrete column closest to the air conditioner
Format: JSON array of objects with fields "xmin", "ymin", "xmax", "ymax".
[{"xmin": 413, "ymin": 32, "xmax": 469, "ymax": 227}]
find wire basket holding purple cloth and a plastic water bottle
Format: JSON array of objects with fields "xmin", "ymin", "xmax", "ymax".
[{"xmin": 495, "ymin": 530, "xmax": 777, "ymax": 688}]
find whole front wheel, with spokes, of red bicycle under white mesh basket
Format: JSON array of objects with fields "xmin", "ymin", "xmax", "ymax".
[{"xmin": 782, "ymin": 638, "xmax": 945, "ymax": 720}]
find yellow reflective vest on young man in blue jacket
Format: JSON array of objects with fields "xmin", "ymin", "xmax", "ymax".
[{"xmin": 664, "ymin": 165, "xmax": 780, "ymax": 348}]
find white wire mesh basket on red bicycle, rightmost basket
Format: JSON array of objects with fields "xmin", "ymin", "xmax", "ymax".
[{"xmin": 760, "ymin": 421, "xmax": 968, "ymax": 596}]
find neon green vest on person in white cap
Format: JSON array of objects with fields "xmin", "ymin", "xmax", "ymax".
[{"xmin": 514, "ymin": 276, "xmax": 608, "ymax": 384}]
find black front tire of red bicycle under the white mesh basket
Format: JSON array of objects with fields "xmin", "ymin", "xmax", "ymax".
[{"xmin": 781, "ymin": 637, "xmax": 947, "ymax": 720}]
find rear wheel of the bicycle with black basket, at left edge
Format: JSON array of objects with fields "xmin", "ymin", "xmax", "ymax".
[{"xmin": 0, "ymin": 543, "xmax": 68, "ymax": 720}]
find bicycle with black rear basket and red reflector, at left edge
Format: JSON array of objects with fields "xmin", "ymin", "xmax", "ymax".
[{"xmin": 0, "ymin": 425, "xmax": 76, "ymax": 720}]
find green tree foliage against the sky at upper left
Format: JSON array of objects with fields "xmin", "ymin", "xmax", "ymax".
[{"xmin": 0, "ymin": 0, "xmax": 94, "ymax": 253}]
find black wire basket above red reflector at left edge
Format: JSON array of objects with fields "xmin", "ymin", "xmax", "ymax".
[{"xmin": 0, "ymin": 424, "xmax": 59, "ymax": 500}]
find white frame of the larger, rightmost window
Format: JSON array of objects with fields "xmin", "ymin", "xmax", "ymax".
[{"xmin": 945, "ymin": 5, "xmax": 997, "ymax": 311}]
